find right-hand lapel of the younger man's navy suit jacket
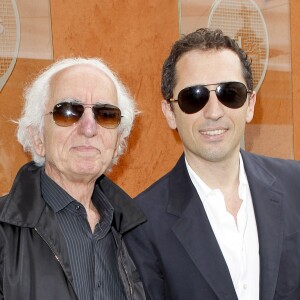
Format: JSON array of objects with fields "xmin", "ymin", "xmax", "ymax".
[{"xmin": 242, "ymin": 151, "xmax": 284, "ymax": 300}]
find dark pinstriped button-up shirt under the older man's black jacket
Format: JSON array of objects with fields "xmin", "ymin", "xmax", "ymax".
[{"xmin": 41, "ymin": 171, "xmax": 126, "ymax": 300}]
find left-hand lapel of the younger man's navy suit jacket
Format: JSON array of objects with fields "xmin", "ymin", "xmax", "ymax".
[{"xmin": 168, "ymin": 156, "xmax": 237, "ymax": 300}]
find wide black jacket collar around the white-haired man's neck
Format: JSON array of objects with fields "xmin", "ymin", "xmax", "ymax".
[{"xmin": 0, "ymin": 162, "xmax": 146, "ymax": 233}]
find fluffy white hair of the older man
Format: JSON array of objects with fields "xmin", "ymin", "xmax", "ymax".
[{"xmin": 17, "ymin": 57, "xmax": 138, "ymax": 166}]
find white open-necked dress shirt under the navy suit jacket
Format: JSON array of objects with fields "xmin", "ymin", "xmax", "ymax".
[{"xmin": 186, "ymin": 155, "xmax": 260, "ymax": 300}]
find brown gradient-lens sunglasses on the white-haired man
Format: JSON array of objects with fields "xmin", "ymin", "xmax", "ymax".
[{"xmin": 46, "ymin": 102, "xmax": 122, "ymax": 129}]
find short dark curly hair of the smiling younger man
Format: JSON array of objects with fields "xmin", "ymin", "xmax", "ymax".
[{"xmin": 161, "ymin": 28, "xmax": 253, "ymax": 100}]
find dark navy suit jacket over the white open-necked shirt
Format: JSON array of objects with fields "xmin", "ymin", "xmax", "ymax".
[{"xmin": 126, "ymin": 151, "xmax": 300, "ymax": 300}]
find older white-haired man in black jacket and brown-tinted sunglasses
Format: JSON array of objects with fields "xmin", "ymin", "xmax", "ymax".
[{"xmin": 0, "ymin": 58, "xmax": 144, "ymax": 300}]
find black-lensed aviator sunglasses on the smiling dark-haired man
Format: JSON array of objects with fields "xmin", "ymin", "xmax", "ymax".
[{"xmin": 170, "ymin": 82, "xmax": 252, "ymax": 114}]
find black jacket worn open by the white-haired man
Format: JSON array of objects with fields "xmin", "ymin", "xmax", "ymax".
[{"xmin": 0, "ymin": 162, "xmax": 146, "ymax": 300}]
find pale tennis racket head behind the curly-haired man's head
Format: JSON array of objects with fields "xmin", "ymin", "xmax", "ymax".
[{"xmin": 208, "ymin": 0, "xmax": 269, "ymax": 92}]
